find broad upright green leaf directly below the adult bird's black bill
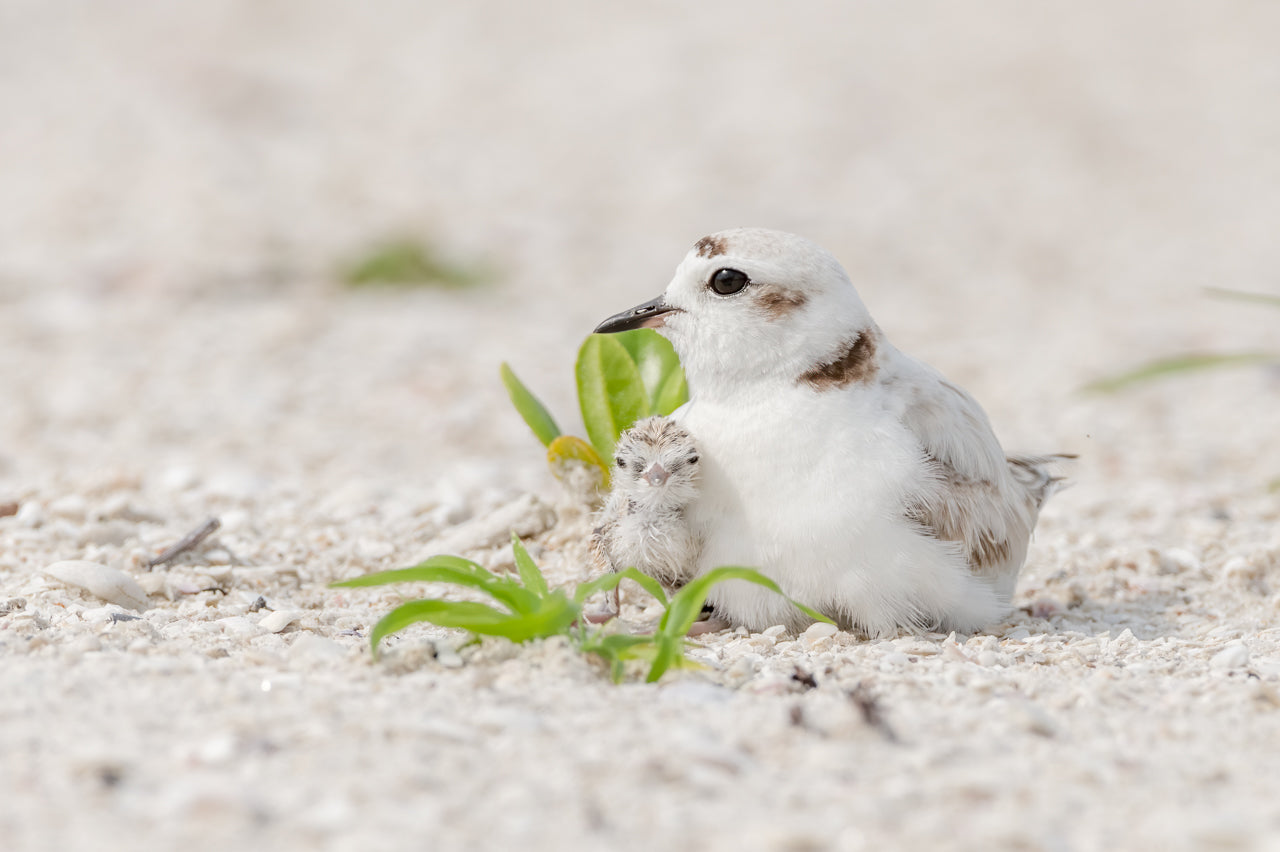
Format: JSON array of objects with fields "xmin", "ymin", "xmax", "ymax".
[{"xmin": 575, "ymin": 334, "xmax": 649, "ymax": 459}]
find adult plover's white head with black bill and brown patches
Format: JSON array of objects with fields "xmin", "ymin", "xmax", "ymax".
[{"xmin": 595, "ymin": 228, "xmax": 879, "ymax": 394}]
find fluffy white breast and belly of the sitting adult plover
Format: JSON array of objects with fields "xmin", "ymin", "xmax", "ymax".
[{"xmin": 678, "ymin": 389, "xmax": 1000, "ymax": 635}]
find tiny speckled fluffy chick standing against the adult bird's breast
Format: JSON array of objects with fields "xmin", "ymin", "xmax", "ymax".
[{"xmin": 591, "ymin": 417, "xmax": 700, "ymax": 608}]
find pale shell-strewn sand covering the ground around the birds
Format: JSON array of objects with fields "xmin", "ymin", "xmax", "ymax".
[{"xmin": 0, "ymin": 0, "xmax": 1280, "ymax": 851}]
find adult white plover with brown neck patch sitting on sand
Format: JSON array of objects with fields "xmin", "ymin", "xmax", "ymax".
[{"xmin": 595, "ymin": 228, "xmax": 1065, "ymax": 636}]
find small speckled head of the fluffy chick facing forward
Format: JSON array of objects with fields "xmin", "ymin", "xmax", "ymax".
[{"xmin": 613, "ymin": 417, "xmax": 699, "ymax": 509}]
